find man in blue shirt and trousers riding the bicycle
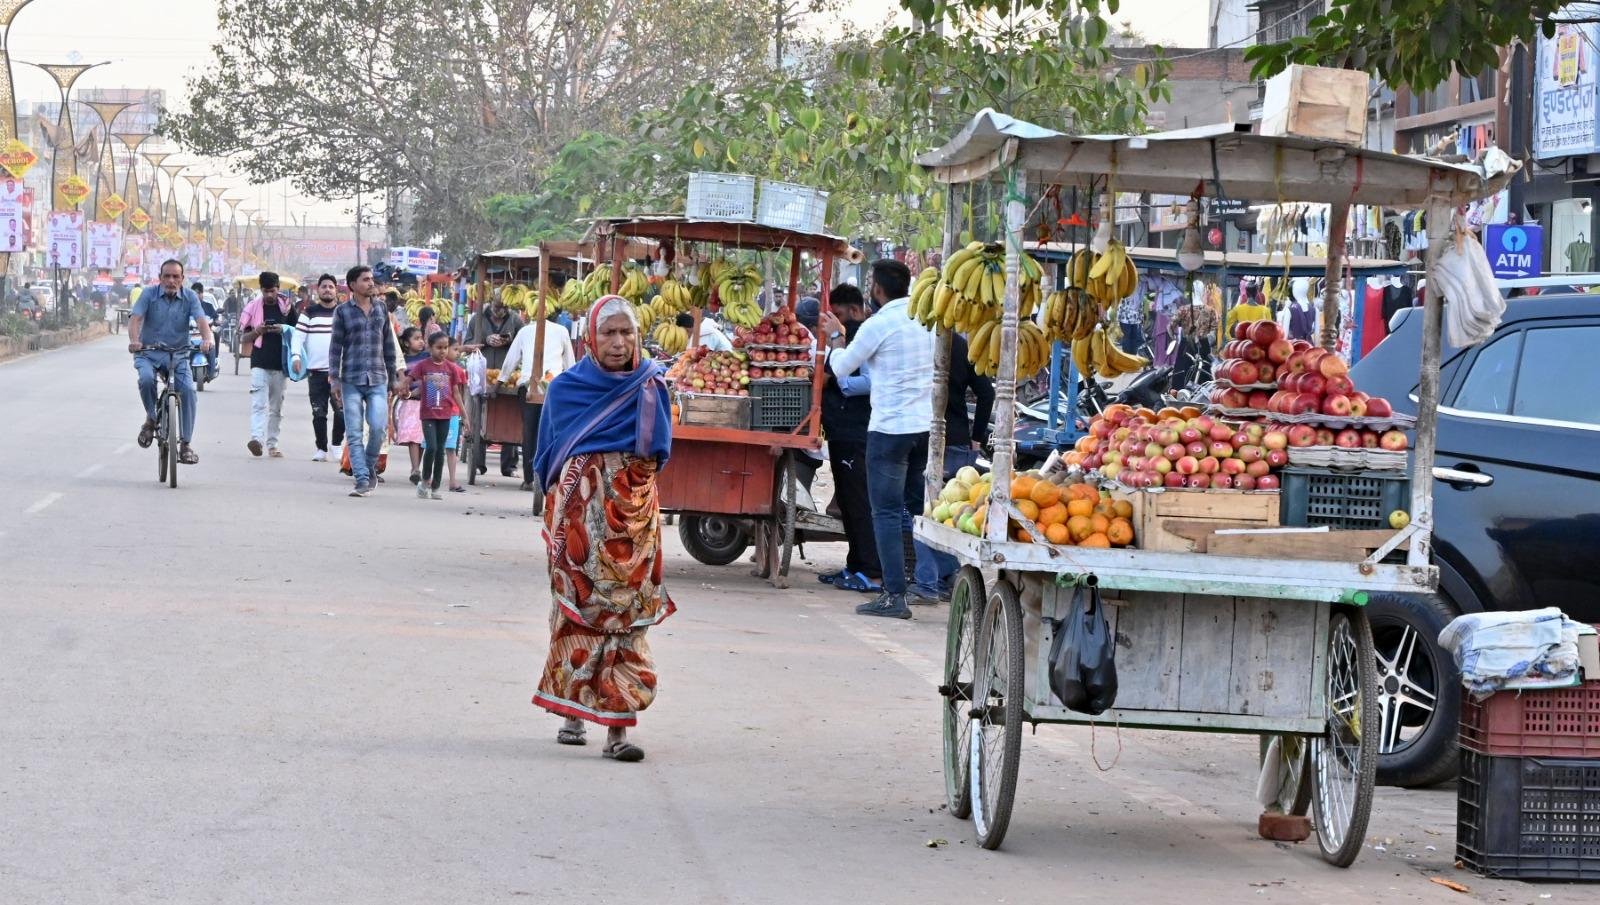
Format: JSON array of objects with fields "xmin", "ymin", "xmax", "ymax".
[{"xmin": 128, "ymin": 259, "xmax": 213, "ymax": 465}]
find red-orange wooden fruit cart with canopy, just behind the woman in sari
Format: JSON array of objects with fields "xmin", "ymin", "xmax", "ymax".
[{"xmin": 592, "ymin": 216, "xmax": 861, "ymax": 587}]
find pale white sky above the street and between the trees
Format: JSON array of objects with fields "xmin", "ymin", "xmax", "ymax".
[{"xmin": 8, "ymin": 0, "xmax": 1206, "ymax": 233}]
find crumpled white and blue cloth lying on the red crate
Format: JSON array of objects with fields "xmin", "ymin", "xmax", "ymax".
[{"xmin": 1438, "ymin": 606, "xmax": 1579, "ymax": 697}]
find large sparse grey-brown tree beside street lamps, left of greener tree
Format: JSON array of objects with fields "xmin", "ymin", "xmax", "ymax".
[{"xmin": 162, "ymin": 0, "xmax": 770, "ymax": 251}]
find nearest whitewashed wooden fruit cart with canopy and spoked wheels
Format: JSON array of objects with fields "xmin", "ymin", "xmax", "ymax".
[{"xmin": 915, "ymin": 112, "xmax": 1507, "ymax": 867}]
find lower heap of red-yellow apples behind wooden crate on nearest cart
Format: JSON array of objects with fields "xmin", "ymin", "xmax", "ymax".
[{"xmin": 1066, "ymin": 403, "xmax": 1290, "ymax": 491}]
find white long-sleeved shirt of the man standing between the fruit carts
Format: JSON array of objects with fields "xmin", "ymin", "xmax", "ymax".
[{"xmin": 827, "ymin": 299, "xmax": 933, "ymax": 433}]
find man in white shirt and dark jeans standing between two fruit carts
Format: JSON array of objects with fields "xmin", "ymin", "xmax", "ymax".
[{"xmin": 819, "ymin": 261, "xmax": 933, "ymax": 619}]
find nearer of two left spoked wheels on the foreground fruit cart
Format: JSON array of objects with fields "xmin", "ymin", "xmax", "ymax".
[{"xmin": 968, "ymin": 577, "xmax": 1022, "ymax": 849}]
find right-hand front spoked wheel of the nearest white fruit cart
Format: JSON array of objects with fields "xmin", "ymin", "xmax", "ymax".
[{"xmin": 1310, "ymin": 608, "xmax": 1378, "ymax": 867}]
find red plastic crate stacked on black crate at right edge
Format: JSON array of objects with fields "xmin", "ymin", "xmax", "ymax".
[{"xmin": 1461, "ymin": 681, "xmax": 1600, "ymax": 758}]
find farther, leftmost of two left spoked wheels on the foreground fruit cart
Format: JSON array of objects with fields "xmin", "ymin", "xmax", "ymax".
[{"xmin": 939, "ymin": 566, "xmax": 984, "ymax": 820}]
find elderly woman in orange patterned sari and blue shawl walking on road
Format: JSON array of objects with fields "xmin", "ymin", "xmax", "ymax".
[{"xmin": 533, "ymin": 296, "xmax": 674, "ymax": 763}]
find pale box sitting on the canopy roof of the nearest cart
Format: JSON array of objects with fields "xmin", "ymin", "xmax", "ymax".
[{"xmin": 1261, "ymin": 64, "xmax": 1368, "ymax": 147}]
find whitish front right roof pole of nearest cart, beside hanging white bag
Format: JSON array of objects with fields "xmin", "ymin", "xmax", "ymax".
[{"xmin": 1406, "ymin": 205, "xmax": 1456, "ymax": 566}]
